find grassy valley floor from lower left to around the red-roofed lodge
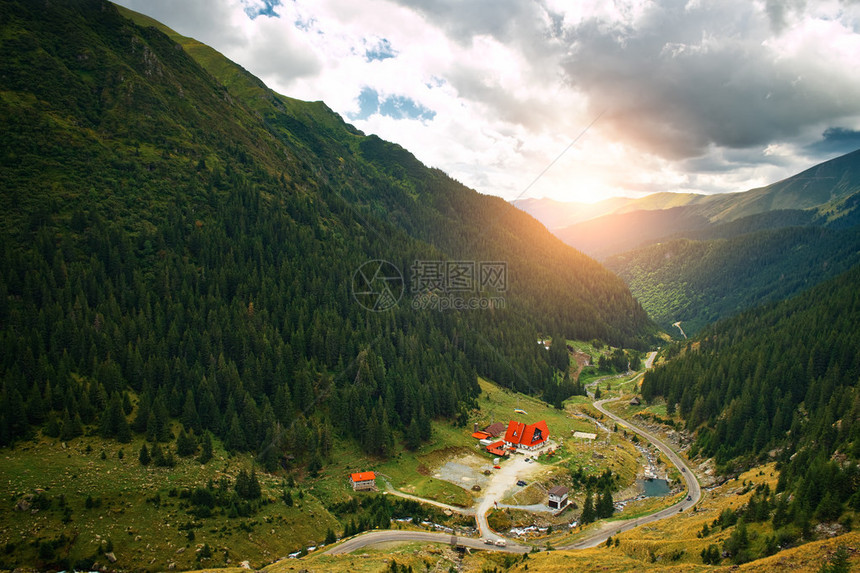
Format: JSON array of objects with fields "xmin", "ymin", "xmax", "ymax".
[{"xmin": 0, "ymin": 356, "xmax": 660, "ymax": 570}]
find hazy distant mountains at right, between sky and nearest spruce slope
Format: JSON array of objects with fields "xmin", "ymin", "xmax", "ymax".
[{"xmin": 516, "ymin": 150, "xmax": 860, "ymax": 334}]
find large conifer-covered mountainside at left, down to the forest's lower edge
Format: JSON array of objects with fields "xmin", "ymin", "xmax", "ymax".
[{"xmin": 0, "ymin": 0, "xmax": 653, "ymax": 456}]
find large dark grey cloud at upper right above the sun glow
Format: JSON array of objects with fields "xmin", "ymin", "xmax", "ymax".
[{"xmin": 564, "ymin": 1, "xmax": 860, "ymax": 159}]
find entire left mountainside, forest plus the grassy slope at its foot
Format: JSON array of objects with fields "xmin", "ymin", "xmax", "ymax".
[{"xmin": 0, "ymin": 0, "xmax": 655, "ymax": 570}]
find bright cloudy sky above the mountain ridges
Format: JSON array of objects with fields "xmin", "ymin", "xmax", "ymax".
[{"xmin": 112, "ymin": 0, "xmax": 860, "ymax": 203}]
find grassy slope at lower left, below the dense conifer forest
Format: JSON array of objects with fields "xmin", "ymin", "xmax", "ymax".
[{"xmin": 0, "ymin": 437, "xmax": 337, "ymax": 570}]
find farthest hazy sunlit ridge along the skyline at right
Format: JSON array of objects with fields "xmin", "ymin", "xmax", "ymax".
[{"xmin": 528, "ymin": 150, "xmax": 860, "ymax": 259}]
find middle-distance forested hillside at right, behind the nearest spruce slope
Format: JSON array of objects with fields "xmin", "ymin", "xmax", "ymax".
[{"xmin": 605, "ymin": 223, "xmax": 860, "ymax": 335}]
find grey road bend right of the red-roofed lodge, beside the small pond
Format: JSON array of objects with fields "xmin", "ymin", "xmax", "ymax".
[{"xmin": 558, "ymin": 398, "xmax": 702, "ymax": 549}]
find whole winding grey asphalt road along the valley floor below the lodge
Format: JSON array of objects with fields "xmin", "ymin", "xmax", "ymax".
[{"xmin": 325, "ymin": 352, "xmax": 702, "ymax": 555}]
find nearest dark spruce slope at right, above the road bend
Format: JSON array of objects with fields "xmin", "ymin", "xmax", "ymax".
[{"xmin": 642, "ymin": 266, "xmax": 860, "ymax": 537}]
